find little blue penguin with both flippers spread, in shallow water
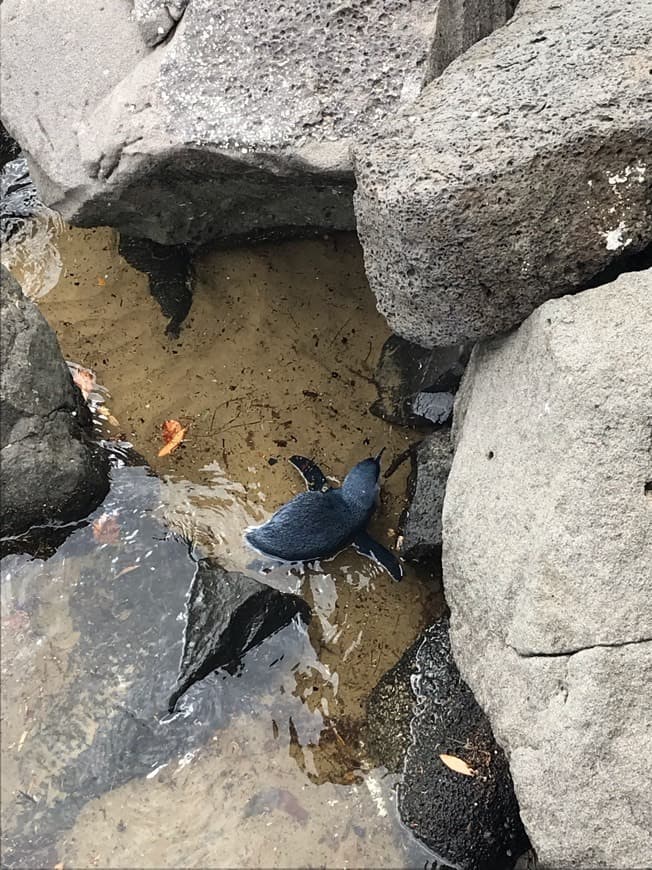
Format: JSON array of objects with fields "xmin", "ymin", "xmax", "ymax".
[{"xmin": 245, "ymin": 450, "xmax": 403, "ymax": 580}]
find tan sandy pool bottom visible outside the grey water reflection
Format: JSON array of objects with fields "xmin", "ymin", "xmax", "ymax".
[{"xmin": 4, "ymin": 229, "xmax": 442, "ymax": 867}]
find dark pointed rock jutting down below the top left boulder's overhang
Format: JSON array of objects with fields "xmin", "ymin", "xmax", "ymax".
[{"xmin": 118, "ymin": 235, "xmax": 193, "ymax": 338}]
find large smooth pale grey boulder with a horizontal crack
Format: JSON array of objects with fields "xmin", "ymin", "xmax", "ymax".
[{"xmin": 443, "ymin": 271, "xmax": 652, "ymax": 870}]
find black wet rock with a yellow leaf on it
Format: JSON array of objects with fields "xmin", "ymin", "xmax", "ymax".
[{"xmin": 368, "ymin": 620, "xmax": 528, "ymax": 870}]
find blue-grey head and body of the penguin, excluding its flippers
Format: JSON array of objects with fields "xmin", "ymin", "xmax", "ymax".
[{"xmin": 245, "ymin": 451, "xmax": 382, "ymax": 562}]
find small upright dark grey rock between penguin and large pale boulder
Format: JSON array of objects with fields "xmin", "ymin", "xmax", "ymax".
[{"xmin": 401, "ymin": 429, "xmax": 453, "ymax": 562}]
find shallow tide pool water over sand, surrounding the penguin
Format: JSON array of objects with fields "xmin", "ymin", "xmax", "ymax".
[{"xmin": 2, "ymin": 230, "xmax": 441, "ymax": 868}]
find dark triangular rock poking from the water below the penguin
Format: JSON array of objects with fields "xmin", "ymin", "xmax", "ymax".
[{"xmin": 168, "ymin": 559, "xmax": 310, "ymax": 712}]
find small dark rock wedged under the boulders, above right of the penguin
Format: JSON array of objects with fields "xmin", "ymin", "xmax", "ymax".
[{"xmin": 371, "ymin": 335, "xmax": 471, "ymax": 426}]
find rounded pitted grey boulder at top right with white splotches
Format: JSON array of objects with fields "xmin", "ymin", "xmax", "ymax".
[{"xmin": 355, "ymin": 0, "xmax": 652, "ymax": 346}]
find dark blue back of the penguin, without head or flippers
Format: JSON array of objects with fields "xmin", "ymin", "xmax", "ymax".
[{"xmin": 245, "ymin": 490, "xmax": 360, "ymax": 562}]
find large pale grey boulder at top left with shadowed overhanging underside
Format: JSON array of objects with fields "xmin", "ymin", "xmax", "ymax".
[{"xmin": 2, "ymin": 0, "xmax": 437, "ymax": 245}]
